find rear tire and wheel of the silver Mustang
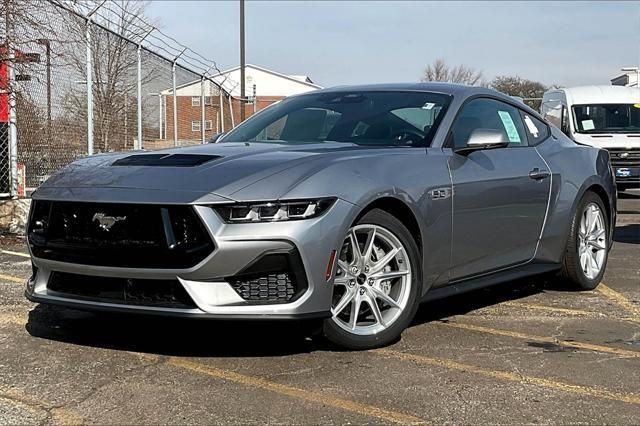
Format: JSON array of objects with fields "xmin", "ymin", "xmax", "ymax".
[{"xmin": 560, "ymin": 192, "xmax": 610, "ymax": 290}]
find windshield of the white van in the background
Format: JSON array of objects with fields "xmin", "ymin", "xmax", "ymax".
[{"xmin": 573, "ymin": 104, "xmax": 640, "ymax": 133}]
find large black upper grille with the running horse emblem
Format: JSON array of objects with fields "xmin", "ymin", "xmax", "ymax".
[{"xmin": 29, "ymin": 200, "xmax": 214, "ymax": 269}]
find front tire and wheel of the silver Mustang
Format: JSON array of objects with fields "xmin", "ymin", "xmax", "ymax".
[{"xmin": 323, "ymin": 209, "xmax": 422, "ymax": 350}]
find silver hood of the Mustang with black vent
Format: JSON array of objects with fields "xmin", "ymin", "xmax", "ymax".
[{"xmin": 34, "ymin": 142, "xmax": 360, "ymax": 202}]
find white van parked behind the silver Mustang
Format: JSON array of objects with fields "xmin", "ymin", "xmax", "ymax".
[{"xmin": 540, "ymin": 86, "xmax": 640, "ymax": 191}]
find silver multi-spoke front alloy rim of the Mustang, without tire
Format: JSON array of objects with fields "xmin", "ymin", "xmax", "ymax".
[{"xmin": 331, "ymin": 225, "xmax": 412, "ymax": 335}]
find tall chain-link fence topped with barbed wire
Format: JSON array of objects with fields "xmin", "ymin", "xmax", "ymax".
[{"xmin": 0, "ymin": 0, "xmax": 237, "ymax": 197}]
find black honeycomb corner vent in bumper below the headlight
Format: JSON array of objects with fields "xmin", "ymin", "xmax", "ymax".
[{"xmin": 227, "ymin": 250, "xmax": 307, "ymax": 303}]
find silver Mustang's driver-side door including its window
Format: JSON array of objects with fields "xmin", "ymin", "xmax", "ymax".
[{"xmin": 447, "ymin": 98, "xmax": 551, "ymax": 281}]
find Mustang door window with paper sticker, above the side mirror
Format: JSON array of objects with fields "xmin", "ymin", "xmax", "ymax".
[{"xmin": 451, "ymin": 98, "xmax": 528, "ymax": 148}]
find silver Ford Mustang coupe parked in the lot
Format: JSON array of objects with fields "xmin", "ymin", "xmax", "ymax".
[{"xmin": 26, "ymin": 84, "xmax": 616, "ymax": 349}]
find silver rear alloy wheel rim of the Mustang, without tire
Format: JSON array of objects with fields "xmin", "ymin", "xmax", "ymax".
[{"xmin": 578, "ymin": 203, "xmax": 607, "ymax": 280}]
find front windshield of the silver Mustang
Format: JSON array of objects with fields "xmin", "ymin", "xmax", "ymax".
[{"xmin": 221, "ymin": 91, "xmax": 451, "ymax": 146}]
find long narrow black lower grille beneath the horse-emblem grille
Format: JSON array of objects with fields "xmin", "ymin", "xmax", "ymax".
[{"xmin": 47, "ymin": 272, "xmax": 196, "ymax": 309}]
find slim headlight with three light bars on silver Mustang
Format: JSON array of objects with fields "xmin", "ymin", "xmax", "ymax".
[{"xmin": 212, "ymin": 198, "xmax": 336, "ymax": 223}]
